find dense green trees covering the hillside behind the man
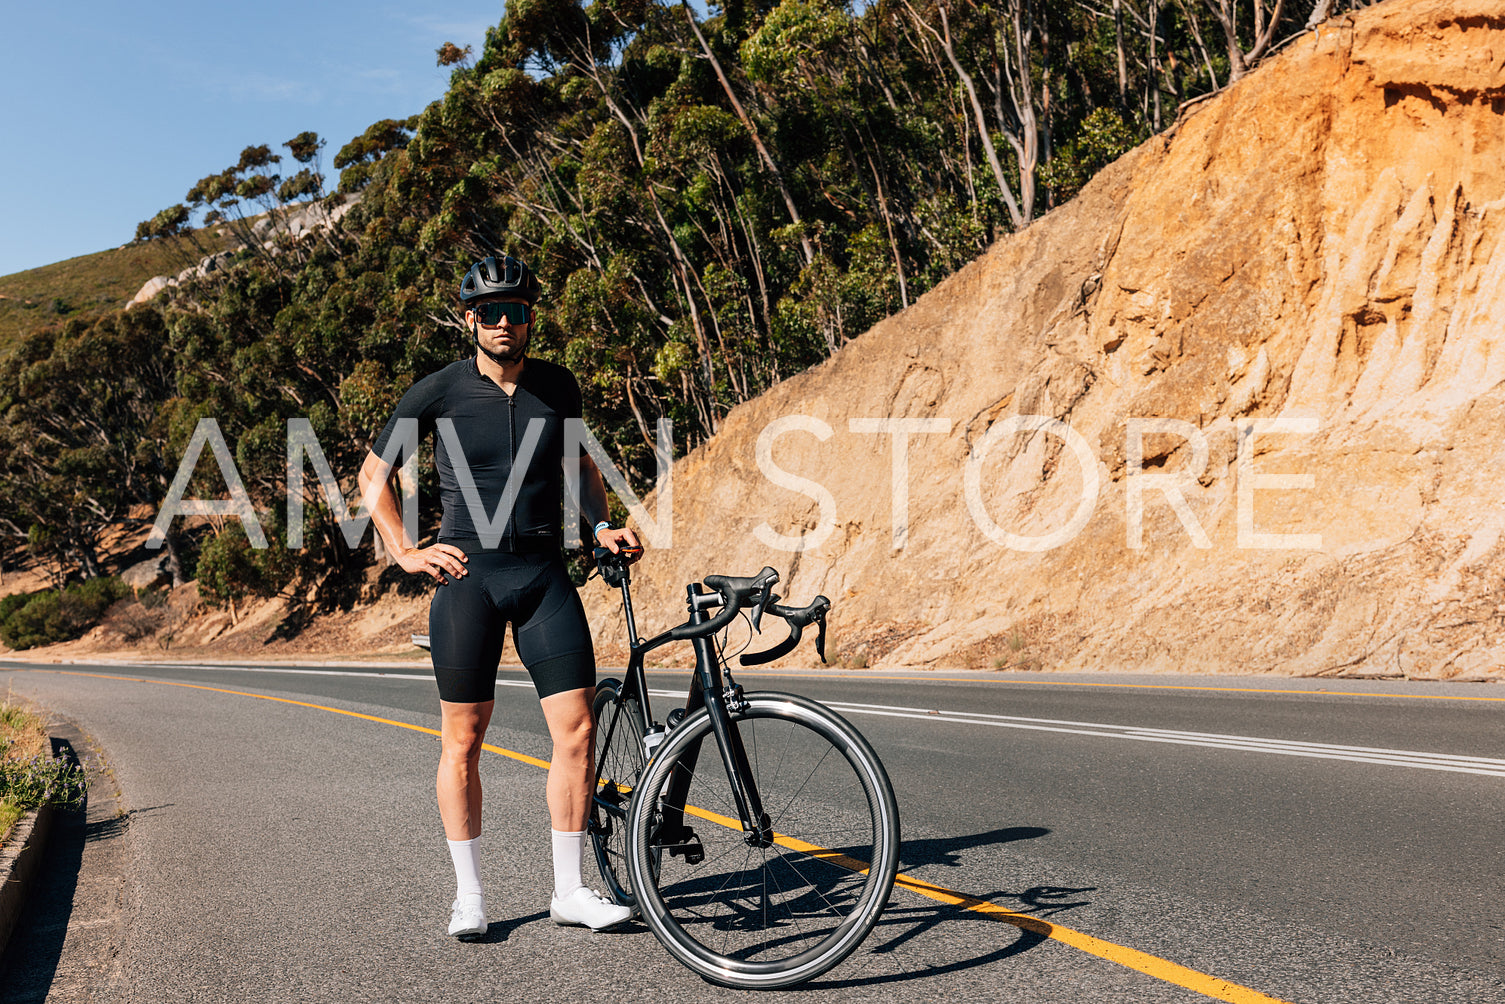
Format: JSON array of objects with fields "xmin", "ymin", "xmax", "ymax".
[{"xmin": 0, "ymin": 0, "xmax": 1359, "ymax": 614}]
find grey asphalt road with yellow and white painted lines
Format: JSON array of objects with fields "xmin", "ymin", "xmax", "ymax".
[{"xmin": 0, "ymin": 665, "xmax": 1505, "ymax": 1004}]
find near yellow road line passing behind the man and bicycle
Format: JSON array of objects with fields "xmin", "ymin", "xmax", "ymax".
[{"xmin": 32, "ymin": 670, "xmax": 1287, "ymax": 1004}]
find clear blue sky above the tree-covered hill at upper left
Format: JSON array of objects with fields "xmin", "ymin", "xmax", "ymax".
[{"xmin": 0, "ymin": 0, "xmax": 490, "ymax": 275}]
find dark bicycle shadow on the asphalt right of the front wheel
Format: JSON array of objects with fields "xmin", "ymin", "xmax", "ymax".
[{"xmin": 790, "ymin": 826, "xmax": 1096, "ymax": 990}]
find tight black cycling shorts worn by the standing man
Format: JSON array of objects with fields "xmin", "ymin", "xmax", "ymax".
[{"xmin": 429, "ymin": 546, "xmax": 596, "ymax": 704}]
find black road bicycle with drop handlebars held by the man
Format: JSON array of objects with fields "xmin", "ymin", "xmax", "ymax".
[{"xmin": 587, "ymin": 548, "xmax": 898, "ymax": 989}]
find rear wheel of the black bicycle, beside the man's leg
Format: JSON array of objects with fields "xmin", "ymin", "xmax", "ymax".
[{"xmin": 585, "ymin": 679, "xmax": 644, "ymax": 906}]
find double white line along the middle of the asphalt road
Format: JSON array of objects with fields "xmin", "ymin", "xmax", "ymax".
[{"xmin": 109, "ymin": 664, "xmax": 1505, "ymax": 777}]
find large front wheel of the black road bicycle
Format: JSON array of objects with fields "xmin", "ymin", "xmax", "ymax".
[{"xmin": 628, "ymin": 692, "xmax": 898, "ymax": 989}]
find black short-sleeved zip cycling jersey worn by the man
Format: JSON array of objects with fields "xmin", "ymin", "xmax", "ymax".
[{"xmin": 372, "ymin": 357, "xmax": 581, "ymax": 551}]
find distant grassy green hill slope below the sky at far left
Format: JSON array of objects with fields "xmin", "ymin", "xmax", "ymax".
[{"xmin": 0, "ymin": 230, "xmax": 232, "ymax": 354}]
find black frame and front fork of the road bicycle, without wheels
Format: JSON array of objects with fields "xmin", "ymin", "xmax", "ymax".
[{"xmin": 608, "ymin": 570, "xmax": 774, "ymax": 847}]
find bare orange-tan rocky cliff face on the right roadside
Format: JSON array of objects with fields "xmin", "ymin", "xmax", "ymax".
[{"xmin": 585, "ymin": 0, "xmax": 1505, "ymax": 677}]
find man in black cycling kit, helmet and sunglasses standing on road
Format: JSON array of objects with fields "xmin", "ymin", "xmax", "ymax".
[{"xmin": 360, "ymin": 256, "xmax": 638, "ymax": 936}]
